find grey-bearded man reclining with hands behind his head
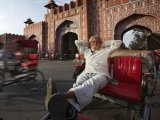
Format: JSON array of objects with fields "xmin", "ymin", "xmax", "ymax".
[{"xmin": 45, "ymin": 35, "xmax": 122, "ymax": 120}]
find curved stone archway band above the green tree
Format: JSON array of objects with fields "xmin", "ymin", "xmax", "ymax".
[{"xmin": 114, "ymin": 14, "xmax": 160, "ymax": 39}]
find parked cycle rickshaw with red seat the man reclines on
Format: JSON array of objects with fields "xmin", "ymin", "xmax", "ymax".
[{"xmin": 41, "ymin": 50, "xmax": 158, "ymax": 120}]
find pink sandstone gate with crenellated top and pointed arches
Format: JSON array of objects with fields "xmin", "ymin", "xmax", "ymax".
[{"xmin": 25, "ymin": 0, "xmax": 160, "ymax": 56}]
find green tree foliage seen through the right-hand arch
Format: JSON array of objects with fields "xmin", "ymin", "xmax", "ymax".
[{"xmin": 129, "ymin": 28, "xmax": 147, "ymax": 50}]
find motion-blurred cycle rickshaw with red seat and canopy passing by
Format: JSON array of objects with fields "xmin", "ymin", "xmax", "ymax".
[{"xmin": 0, "ymin": 40, "xmax": 45, "ymax": 90}]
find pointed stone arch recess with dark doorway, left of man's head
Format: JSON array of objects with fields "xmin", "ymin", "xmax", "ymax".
[{"xmin": 55, "ymin": 20, "xmax": 78, "ymax": 58}]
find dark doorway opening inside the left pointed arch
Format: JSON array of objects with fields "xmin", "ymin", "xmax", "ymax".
[{"xmin": 61, "ymin": 32, "xmax": 78, "ymax": 59}]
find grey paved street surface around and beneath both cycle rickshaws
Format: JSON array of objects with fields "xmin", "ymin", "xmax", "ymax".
[{"xmin": 0, "ymin": 60, "xmax": 160, "ymax": 120}]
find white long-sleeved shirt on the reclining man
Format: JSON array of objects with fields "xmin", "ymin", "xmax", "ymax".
[{"xmin": 75, "ymin": 40, "xmax": 122, "ymax": 76}]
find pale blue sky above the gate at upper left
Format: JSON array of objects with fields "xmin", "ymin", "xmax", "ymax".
[{"xmin": 0, "ymin": 0, "xmax": 71, "ymax": 35}]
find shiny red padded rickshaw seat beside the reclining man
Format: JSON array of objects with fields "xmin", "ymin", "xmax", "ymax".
[{"xmin": 99, "ymin": 56, "xmax": 142, "ymax": 103}]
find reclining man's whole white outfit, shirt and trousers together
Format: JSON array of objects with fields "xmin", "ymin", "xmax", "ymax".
[{"xmin": 68, "ymin": 40, "xmax": 122, "ymax": 111}]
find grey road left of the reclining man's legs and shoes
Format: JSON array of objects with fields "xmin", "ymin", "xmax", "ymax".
[{"xmin": 0, "ymin": 61, "xmax": 76, "ymax": 120}]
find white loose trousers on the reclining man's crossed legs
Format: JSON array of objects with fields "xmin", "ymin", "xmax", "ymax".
[{"xmin": 68, "ymin": 72, "xmax": 110, "ymax": 111}]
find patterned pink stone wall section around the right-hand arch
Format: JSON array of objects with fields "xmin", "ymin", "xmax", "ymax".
[{"xmin": 104, "ymin": 0, "xmax": 160, "ymax": 40}]
